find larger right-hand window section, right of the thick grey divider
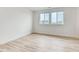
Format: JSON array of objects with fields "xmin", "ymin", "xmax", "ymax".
[{"xmin": 51, "ymin": 12, "xmax": 64, "ymax": 24}]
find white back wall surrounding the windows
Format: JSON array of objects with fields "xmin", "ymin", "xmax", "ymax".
[{"xmin": 33, "ymin": 8, "xmax": 79, "ymax": 36}]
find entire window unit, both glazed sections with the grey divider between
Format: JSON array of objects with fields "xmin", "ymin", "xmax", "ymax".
[{"xmin": 40, "ymin": 11, "xmax": 64, "ymax": 24}]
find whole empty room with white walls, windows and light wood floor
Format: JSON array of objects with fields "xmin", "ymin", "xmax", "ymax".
[{"xmin": 0, "ymin": 7, "xmax": 79, "ymax": 52}]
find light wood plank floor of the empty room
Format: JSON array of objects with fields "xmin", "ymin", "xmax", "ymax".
[{"xmin": 0, "ymin": 34, "xmax": 79, "ymax": 52}]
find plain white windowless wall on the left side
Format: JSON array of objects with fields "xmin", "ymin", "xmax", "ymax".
[{"xmin": 0, "ymin": 7, "xmax": 32, "ymax": 44}]
